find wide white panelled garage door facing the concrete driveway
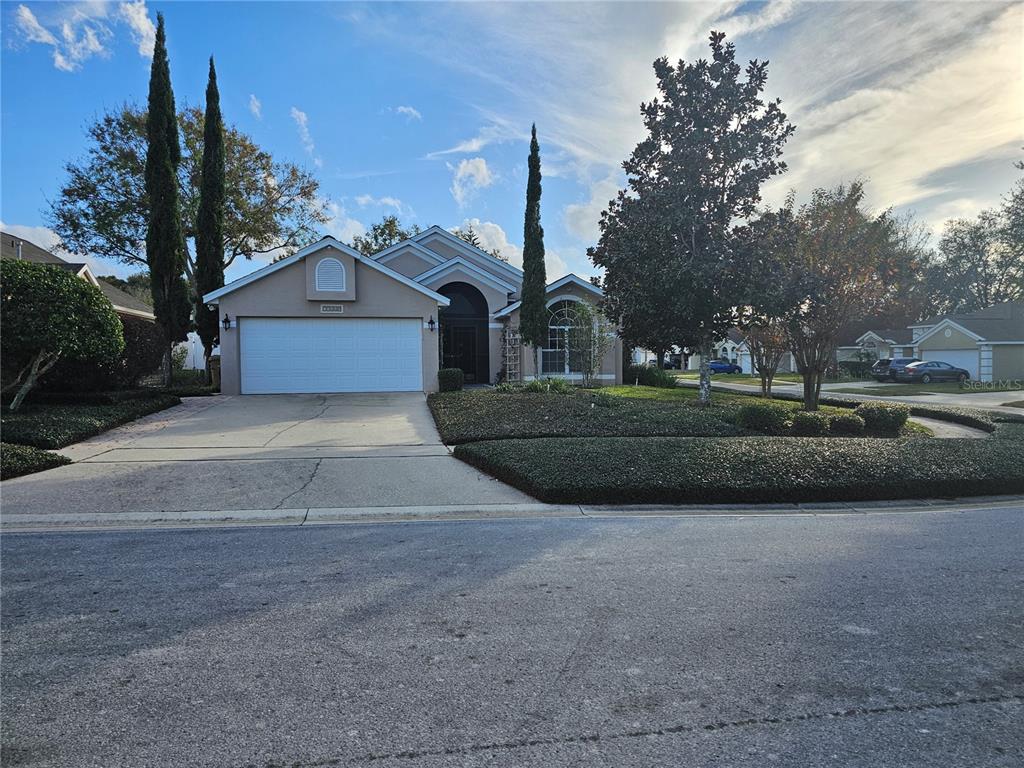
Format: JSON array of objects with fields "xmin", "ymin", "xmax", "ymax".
[{"xmin": 240, "ymin": 317, "xmax": 423, "ymax": 394}]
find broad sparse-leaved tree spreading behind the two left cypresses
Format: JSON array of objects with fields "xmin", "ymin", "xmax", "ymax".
[{"xmin": 48, "ymin": 104, "xmax": 329, "ymax": 291}]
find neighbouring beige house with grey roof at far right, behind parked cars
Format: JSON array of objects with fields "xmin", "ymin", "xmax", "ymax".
[{"xmin": 839, "ymin": 301, "xmax": 1024, "ymax": 382}]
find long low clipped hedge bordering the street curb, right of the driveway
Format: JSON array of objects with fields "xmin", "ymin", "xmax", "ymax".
[{"xmin": 455, "ymin": 437, "xmax": 1024, "ymax": 504}]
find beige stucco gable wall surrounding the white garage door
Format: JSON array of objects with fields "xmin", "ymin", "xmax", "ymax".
[{"xmin": 218, "ymin": 249, "xmax": 438, "ymax": 394}]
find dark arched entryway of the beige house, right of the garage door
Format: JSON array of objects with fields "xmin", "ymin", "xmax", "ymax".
[{"xmin": 438, "ymin": 283, "xmax": 490, "ymax": 384}]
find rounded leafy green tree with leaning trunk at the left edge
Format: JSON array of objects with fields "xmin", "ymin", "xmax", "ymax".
[{"xmin": 0, "ymin": 259, "xmax": 125, "ymax": 411}]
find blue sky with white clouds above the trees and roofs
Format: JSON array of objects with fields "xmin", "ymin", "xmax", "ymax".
[{"xmin": 0, "ymin": 0, "xmax": 1024, "ymax": 286}]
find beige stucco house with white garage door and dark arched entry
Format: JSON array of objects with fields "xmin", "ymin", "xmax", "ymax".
[{"xmin": 198, "ymin": 226, "xmax": 622, "ymax": 394}]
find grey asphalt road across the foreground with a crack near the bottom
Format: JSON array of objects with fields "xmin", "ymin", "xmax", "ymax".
[{"xmin": 2, "ymin": 508, "xmax": 1024, "ymax": 768}]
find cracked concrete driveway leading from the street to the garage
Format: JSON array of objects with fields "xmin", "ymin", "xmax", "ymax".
[{"xmin": 3, "ymin": 393, "xmax": 532, "ymax": 515}]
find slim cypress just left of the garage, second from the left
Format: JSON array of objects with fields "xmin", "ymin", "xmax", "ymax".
[{"xmin": 196, "ymin": 56, "xmax": 224, "ymax": 375}]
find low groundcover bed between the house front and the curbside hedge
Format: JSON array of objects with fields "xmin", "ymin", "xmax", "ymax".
[{"xmin": 427, "ymin": 390, "xmax": 743, "ymax": 445}]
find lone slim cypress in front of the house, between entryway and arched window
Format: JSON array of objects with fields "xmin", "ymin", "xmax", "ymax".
[{"xmin": 519, "ymin": 124, "xmax": 548, "ymax": 378}]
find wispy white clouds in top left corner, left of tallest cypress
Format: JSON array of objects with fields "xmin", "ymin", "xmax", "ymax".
[{"xmin": 14, "ymin": 0, "xmax": 157, "ymax": 72}]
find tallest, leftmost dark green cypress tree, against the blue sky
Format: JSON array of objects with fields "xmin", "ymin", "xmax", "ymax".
[{"xmin": 145, "ymin": 13, "xmax": 191, "ymax": 382}]
